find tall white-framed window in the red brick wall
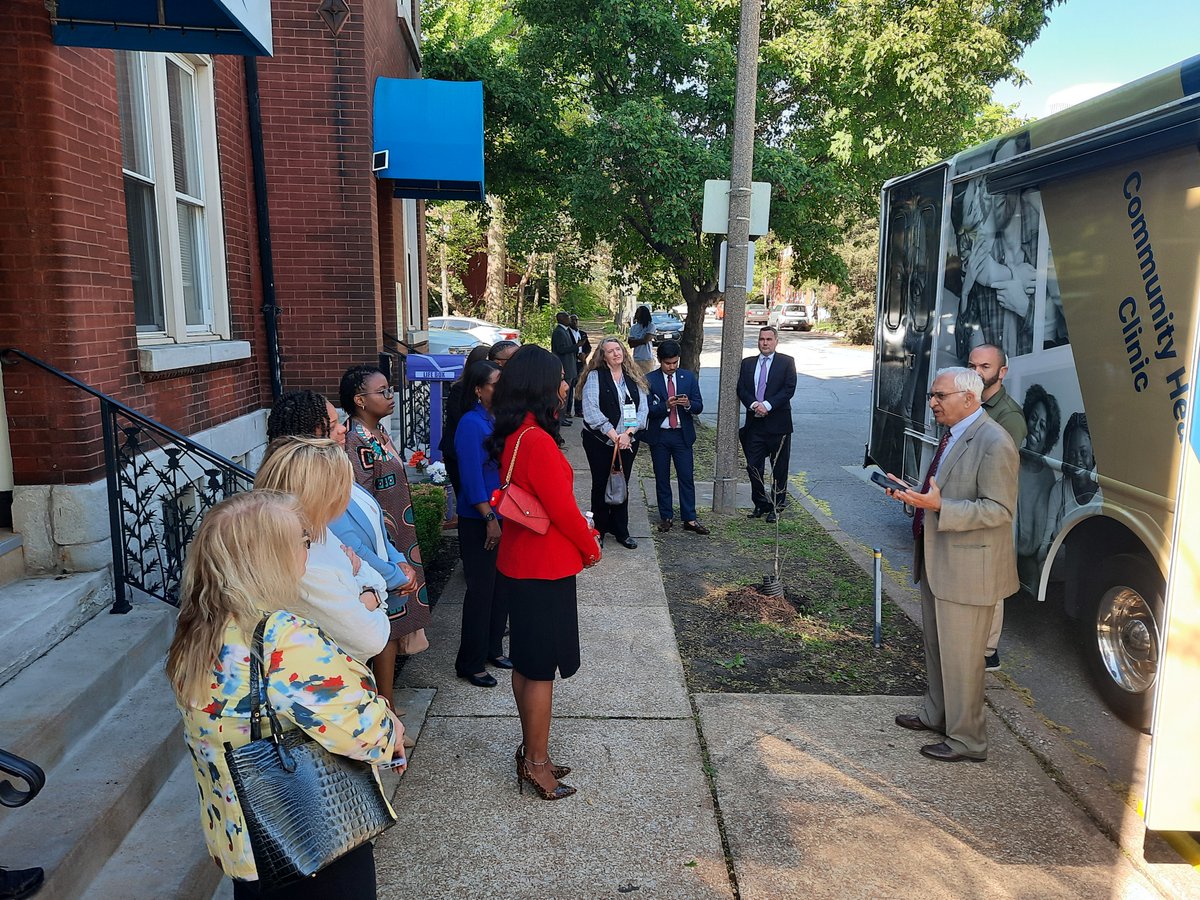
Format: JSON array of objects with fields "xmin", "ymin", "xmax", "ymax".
[{"xmin": 116, "ymin": 52, "xmax": 229, "ymax": 344}]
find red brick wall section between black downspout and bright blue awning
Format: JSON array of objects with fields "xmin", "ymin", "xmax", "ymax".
[{"xmin": 259, "ymin": 0, "xmax": 422, "ymax": 396}]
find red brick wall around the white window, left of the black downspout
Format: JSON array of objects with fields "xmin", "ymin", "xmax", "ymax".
[{"xmin": 0, "ymin": 0, "xmax": 264, "ymax": 484}]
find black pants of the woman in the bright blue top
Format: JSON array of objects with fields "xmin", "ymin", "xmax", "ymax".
[{"xmin": 454, "ymin": 516, "xmax": 504, "ymax": 676}]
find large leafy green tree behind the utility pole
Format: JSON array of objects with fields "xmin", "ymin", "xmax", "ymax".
[{"xmin": 425, "ymin": 0, "xmax": 1057, "ymax": 368}]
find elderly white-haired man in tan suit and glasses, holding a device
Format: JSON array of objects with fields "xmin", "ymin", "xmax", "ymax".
[{"xmin": 888, "ymin": 367, "xmax": 1019, "ymax": 762}]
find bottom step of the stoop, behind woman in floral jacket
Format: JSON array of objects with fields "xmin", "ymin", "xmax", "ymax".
[{"xmin": 83, "ymin": 752, "xmax": 225, "ymax": 900}]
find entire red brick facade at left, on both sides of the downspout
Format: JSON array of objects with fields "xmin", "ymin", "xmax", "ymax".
[{"xmin": 0, "ymin": 0, "xmax": 424, "ymax": 484}]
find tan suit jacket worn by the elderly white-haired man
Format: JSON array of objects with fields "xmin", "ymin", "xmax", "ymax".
[{"xmin": 912, "ymin": 413, "xmax": 1020, "ymax": 606}]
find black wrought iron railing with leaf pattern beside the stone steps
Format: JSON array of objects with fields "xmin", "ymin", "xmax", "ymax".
[{"xmin": 0, "ymin": 348, "xmax": 254, "ymax": 613}]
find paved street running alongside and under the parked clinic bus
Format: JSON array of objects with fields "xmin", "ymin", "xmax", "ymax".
[{"xmin": 697, "ymin": 319, "xmax": 1150, "ymax": 797}]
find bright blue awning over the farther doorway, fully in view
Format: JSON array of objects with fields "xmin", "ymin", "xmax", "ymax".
[{"xmin": 374, "ymin": 78, "xmax": 484, "ymax": 200}]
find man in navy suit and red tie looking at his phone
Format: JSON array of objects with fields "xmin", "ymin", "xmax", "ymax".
[{"xmin": 646, "ymin": 341, "xmax": 708, "ymax": 534}]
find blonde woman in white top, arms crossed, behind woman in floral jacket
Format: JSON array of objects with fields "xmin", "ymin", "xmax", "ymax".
[{"xmin": 254, "ymin": 436, "xmax": 391, "ymax": 667}]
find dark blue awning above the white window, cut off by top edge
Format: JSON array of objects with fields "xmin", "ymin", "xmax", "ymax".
[{"xmin": 50, "ymin": 0, "xmax": 271, "ymax": 56}]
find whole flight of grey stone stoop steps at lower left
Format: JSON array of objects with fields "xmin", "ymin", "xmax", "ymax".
[{"xmin": 0, "ymin": 592, "xmax": 221, "ymax": 900}]
